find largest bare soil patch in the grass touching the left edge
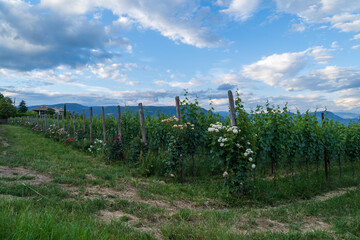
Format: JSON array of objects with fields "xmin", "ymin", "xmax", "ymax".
[{"xmin": 0, "ymin": 166, "xmax": 51, "ymax": 184}]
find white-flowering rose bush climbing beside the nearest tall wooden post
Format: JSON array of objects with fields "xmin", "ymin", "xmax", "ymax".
[{"xmin": 208, "ymin": 99, "xmax": 256, "ymax": 197}]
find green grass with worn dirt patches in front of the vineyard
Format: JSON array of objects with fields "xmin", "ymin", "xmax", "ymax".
[{"xmin": 0, "ymin": 125, "xmax": 360, "ymax": 239}]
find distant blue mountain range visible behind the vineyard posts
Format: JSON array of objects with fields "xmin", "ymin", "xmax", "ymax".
[{"xmin": 28, "ymin": 103, "xmax": 359, "ymax": 124}]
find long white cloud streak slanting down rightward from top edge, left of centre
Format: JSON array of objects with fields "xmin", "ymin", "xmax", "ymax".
[{"xmin": 41, "ymin": 0, "xmax": 224, "ymax": 48}]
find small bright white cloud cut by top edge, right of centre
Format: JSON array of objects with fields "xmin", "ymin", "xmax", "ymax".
[{"xmin": 218, "ymin": 0, "xmax": 260, "ymax": 21}]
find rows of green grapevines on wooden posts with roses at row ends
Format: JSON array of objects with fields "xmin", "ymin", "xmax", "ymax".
[{"xmin": 9, "ymin": 91, "xmax": 360, "ymax": 199}]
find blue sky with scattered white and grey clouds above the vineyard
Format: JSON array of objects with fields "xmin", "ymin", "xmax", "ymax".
[{"xmin": 0, "ymin": 0, "xmax": 360, "ymax": 114}]
